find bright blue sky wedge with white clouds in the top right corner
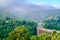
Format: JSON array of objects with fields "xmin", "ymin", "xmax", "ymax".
[{"xmin": 27, "ymin": 0, "xmax": 60, "ymax": 7}]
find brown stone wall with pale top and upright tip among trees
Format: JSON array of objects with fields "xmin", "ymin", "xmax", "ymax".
[{"xmin": 37, "ymin": 22, "xmax": 60, "ymax": 34}]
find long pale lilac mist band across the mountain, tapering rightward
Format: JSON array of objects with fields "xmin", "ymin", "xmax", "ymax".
[{"xmin": 10, "ymin": 6, "xmax": 37, "ymax": 13}]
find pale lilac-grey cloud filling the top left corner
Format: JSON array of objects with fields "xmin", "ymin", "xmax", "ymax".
[{"xmin": 0, "ymin": 0, "xmax": 26, "ymax": 7}]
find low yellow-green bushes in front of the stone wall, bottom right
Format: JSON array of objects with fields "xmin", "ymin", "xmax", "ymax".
[{"xmin": 31, "ymin": 31, "xmax": 60, "ymax": 40}]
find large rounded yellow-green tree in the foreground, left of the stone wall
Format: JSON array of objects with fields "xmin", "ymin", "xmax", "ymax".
[{"xmin": 7, "ymin": 26, "xmax": 30, "ymax": 40}]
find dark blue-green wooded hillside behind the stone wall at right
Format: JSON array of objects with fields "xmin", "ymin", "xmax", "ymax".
[{"xmin": 43, "ymin": 16, "xmax": 60, "ymax": 31}]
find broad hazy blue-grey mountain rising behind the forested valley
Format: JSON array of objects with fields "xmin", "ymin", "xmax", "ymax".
[{"xmin": 8, "ymin": 4, "xmax": 60, "ymax": 21}]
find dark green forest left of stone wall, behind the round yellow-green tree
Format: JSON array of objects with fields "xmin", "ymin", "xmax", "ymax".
[{"xmin": 0, "ymin": 17, "xmax": 37, "ymax": 40}]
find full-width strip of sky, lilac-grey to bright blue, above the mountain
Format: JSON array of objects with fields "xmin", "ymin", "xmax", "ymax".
[{"xmin": 0, "ymin": 0, "xmax": 60, "ymax": 6}]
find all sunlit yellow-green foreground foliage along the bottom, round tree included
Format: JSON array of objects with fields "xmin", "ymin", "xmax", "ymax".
[{"xmin": 7, "ymin": 26, "xmax": 60, "ymax": 40}]
